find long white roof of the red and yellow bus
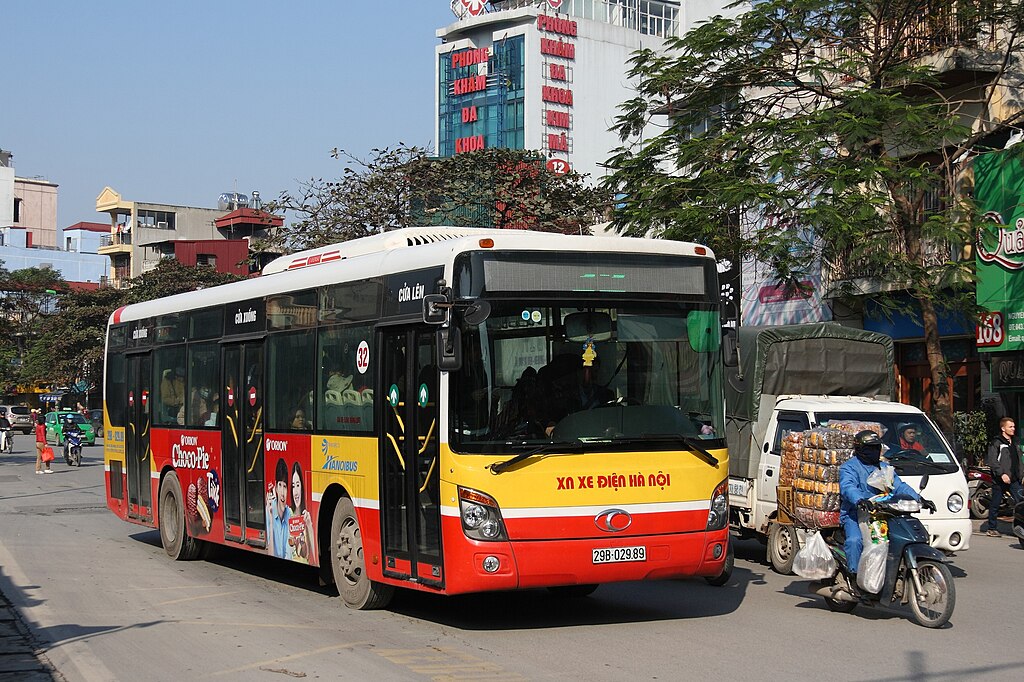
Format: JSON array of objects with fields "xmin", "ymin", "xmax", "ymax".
[{"xmin": 111, "ymin": 227, "xmax": 715, "ymax": 324}]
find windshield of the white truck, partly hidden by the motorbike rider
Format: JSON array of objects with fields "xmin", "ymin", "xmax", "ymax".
[{"xmin": 816, "ymin": 412, "xmax": 958, "ymax": 476}]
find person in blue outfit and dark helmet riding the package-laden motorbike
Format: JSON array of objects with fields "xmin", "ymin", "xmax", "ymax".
[{"xmin": 839, "ymin": 429, "xmax": 931, "ymax": 583}]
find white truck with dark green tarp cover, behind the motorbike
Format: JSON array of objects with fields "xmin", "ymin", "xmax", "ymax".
[{"xmin": 725, "ymin": 323, "xmax": 971, "ymax": 572}]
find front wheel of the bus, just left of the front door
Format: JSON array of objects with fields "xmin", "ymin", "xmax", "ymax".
[{"xmin": 331, "ymin": 498, "xmax": 394, "ymax": 610}]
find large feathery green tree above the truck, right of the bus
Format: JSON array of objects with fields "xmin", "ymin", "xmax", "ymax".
[{"xmin": 605, "ymin": 0, "xmax": 1024, "ymax": 428}]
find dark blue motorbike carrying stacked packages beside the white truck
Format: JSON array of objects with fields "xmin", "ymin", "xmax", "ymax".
[{"xmin": 812, "ymin": 476, "xmax": 956, "ymax": 628}]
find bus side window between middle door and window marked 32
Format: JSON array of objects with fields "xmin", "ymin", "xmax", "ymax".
[{"xmin": 265, "ymin": 332, "xmax": 316, "ymax": 431}]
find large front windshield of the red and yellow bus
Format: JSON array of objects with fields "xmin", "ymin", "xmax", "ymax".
[{"xmin": 450, "ymin": 300, "xmax": 725, "ymax": 453}]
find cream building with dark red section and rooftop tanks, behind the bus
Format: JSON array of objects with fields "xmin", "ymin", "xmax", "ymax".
[{"xmin": 96, "ymin": 187, "xmax": 284, "ymax": 287}]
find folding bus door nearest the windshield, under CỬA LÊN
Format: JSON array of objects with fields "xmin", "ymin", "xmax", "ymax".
[{"xmin": 377, "ymin": 329, "xmax": 444, "ymax": 587}]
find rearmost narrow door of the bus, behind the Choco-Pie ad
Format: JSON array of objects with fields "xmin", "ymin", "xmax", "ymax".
[{"xmin": 125, "ymin": 353, "xmax": 153, "ymax": 521}]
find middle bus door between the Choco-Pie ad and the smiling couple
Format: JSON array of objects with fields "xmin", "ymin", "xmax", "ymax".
[{"xmin": 220, "ymin": 341, "xmax": 267, "ymax": 547}]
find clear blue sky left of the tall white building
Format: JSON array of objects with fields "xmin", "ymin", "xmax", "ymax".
[{"xmin": 0, "ymin": 0, "xmax": 456, "ymax": 228}]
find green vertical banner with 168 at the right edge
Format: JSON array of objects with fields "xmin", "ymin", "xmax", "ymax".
[{"xmin": 974, "ymin": 152, "xmax": 1024, "ymax": 352}]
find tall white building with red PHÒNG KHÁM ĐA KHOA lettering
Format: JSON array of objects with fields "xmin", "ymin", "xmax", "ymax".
[{"xmin": 433, "ymin": 0, "xmax": 728, "ymax": 178}]
